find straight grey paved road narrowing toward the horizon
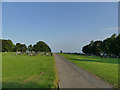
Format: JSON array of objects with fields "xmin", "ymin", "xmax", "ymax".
[{"xmin": 54, "ymin": 54, "xmax": 112, "ymax": 88}]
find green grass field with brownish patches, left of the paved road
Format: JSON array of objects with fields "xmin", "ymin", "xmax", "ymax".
[{"xmin": 2, "ymin": 53, "xmax": 57, "ymax": 88}]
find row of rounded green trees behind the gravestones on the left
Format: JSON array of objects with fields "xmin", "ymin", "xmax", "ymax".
[{"xmin": 0, "ymin": 39, "xmax": 51, "ymax": 52}]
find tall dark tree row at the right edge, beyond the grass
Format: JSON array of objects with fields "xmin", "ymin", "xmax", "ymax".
[{"xmin": 82, "ymin": 34, "xmax": 120, "ymax": 57}]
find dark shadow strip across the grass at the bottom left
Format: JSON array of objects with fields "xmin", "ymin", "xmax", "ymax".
[{"xmin": 2, "ymin": 82, "xmax": 54, "ymax": 90}]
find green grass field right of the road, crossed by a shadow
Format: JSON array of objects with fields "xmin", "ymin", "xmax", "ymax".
[{"xmin": 59, "ymin": 53, "xmax": 118, "ymax": 88}]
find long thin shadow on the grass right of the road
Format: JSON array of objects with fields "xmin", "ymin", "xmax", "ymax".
[{"xmin": 69, "ymin": 58, "xmax": 120, "ymax": 64}]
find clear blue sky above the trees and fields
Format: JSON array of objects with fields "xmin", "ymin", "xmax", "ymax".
[{"xmin": 2, "ymin": 2, "xmax": 118, "ymax": 52}]
